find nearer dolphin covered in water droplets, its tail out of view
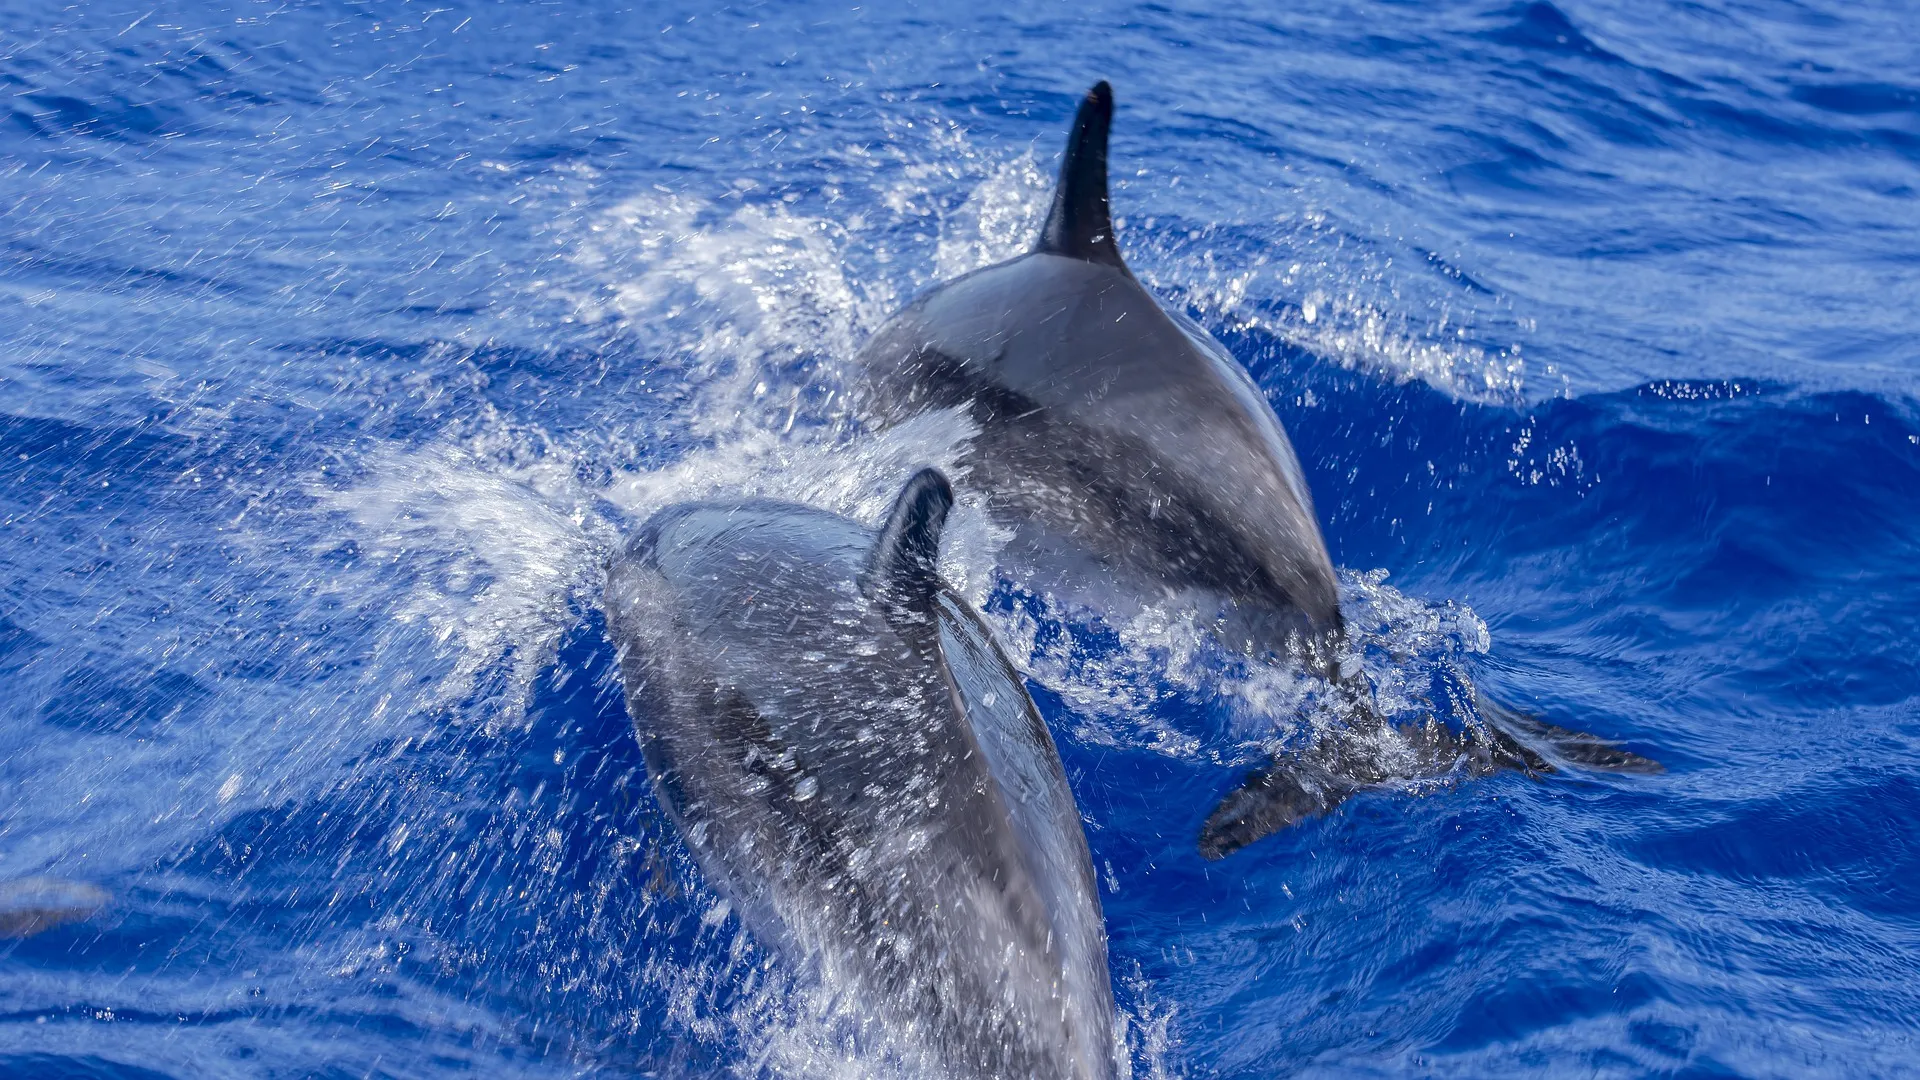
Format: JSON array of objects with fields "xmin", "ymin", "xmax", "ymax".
[{"xmin": 607, "ymin": 469, "xmax": 1116, "ymax": 1080}]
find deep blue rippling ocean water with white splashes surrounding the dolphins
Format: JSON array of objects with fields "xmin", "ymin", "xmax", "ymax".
[{"xmin": 0, "ymin": 0, "xmax": 1920, "ymax": 1080}]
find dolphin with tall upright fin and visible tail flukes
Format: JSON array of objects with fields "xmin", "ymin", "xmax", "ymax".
[{"xmin": 852, "ymin": 83, "xmax": 1659, "ymax": 859}]
